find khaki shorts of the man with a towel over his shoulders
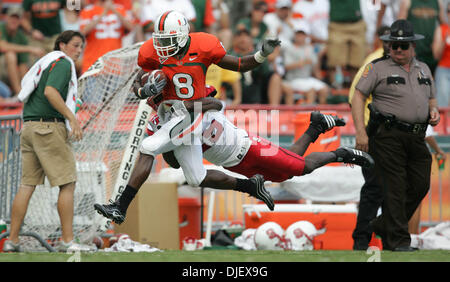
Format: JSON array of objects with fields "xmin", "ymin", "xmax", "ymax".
[{"xmin": 20, "ymin": 121, "xmax": 76, "ymax": 187}]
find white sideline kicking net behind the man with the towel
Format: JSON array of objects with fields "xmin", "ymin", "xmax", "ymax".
[{"xmin": 21, "ymin": 43, "xmax": 145, "ymax": 251}]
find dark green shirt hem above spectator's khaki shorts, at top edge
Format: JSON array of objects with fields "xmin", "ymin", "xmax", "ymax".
[{"xmin": 330, "ymin": 0, "xmax": 362, "ymax": 22}]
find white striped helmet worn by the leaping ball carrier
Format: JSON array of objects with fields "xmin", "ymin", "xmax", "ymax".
[{"xmin": 152, "ymin": 11, "xmax": 189, "ymax": 58}]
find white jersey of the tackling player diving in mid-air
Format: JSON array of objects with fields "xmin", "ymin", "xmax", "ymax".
[{"xmin": 202, "ymin": 111, "xmax": 252, "ymax": 167}]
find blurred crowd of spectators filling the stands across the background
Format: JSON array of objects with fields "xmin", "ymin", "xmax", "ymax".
[{"xmin": 0, "ymin": 0, "xmax": 450, "ymax": 107}]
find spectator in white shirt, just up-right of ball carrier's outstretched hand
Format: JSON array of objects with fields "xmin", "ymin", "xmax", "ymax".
[{"xmin": 263, "ymin": 0, "xmax": 295, "ymax": 44}]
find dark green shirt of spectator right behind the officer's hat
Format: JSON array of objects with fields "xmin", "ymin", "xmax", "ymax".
[{"xmin": 407, "ymin": 0, "xmax": 439, "ymax": 72}]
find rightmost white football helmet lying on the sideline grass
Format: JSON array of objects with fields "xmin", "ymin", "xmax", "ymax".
[{"xmin": 285, "ymin": 220, "xmax": 325, "ymax": 251}]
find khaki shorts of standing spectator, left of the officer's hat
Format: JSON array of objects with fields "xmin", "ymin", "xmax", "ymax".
[{"xmin": 327, "ymin": 20, "xmax": 366, "ymax": 68}]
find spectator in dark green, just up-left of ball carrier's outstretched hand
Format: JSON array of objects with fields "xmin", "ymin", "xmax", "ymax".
[{"xmin": 235, "ymin": 1, "xmax": 267, "ymax": 46}]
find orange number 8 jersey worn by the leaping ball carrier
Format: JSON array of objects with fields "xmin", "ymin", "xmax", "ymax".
[{"xmin": 138, "ymin": 32, "xmax": 226, "ymax": 100}]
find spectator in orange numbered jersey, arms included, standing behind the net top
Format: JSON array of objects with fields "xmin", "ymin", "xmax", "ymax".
[{"xmin": 80, "ymin": 0, "xmax": 134, "ymax": 73}]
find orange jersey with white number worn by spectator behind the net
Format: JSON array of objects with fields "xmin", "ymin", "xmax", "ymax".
[{"xmin": 80, "ymin": 5, "xmax": 127, "ymax": 72}]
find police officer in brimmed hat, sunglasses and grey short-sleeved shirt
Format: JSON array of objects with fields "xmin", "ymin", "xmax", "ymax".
[{"xmin": 352, "ymin": 20, "xmax": 440, "ymax": 251}]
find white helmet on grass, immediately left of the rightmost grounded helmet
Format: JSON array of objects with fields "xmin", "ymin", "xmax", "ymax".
[{"xmin": 254, "ymin": 221, "xmax": 285, "ymax": 250}]
